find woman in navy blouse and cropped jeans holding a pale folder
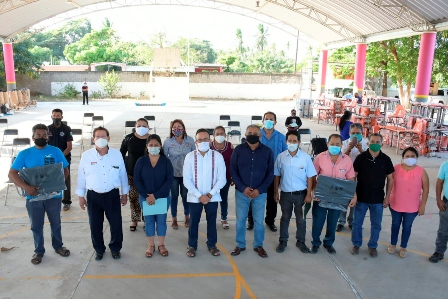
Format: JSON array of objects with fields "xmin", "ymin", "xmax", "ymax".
[{"xmin": 134, "ymin": 134, "xmax": 174, "ymax": 257}]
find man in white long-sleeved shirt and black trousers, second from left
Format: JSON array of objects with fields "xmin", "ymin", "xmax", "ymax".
[{"xmin": 76, "ymin": 127, "xmax": 129, "ymax": 261}]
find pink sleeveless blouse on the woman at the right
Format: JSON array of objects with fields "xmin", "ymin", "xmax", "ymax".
[{"xmin": 389, "ymin": 164, "xmax": 423, "ymax": 213}]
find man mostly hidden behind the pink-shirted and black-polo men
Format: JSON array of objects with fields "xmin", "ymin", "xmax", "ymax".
[{"xmin": 336, "ymin": 123, "xmax": 369, "ymax": 232}]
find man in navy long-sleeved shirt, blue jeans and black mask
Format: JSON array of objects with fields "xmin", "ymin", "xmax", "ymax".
[{"xmin": 230, "ymin": 125, "xmax": 274, "ymax": 258}]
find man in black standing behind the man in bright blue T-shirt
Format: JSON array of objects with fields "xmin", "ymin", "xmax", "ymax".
[{"xmin": 48, "ymin": 109, "xmax": 73, "ymax": 211}]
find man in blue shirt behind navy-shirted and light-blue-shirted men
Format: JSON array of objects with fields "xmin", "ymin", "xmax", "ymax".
[{"xmin": 247, "ymin": 111, "xmax": 287, "ymax": 232}]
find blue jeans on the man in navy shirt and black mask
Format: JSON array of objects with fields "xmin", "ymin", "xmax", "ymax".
[{"xmin": 235, "ymin": 189, "xmax": 266, "ymax": 248}]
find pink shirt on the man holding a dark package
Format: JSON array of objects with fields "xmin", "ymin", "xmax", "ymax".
[{"xmin": 314, "ymin": 151, "xmax": 355, "ymax": 180}]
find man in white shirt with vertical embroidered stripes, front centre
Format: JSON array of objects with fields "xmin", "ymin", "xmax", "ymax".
[{"xmin": 183, "ymin": 129, "xmax": 227, "ymax": 257}]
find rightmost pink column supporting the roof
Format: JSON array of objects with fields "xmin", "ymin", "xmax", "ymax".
[{"xmin": 415, "ymin": 32, "xmax": 437, "ymax": 102}]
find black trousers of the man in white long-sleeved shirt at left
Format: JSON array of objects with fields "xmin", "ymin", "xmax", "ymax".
[{"xmin": 87, "ymin": 189, "xmax": 123, "ymax": 253}]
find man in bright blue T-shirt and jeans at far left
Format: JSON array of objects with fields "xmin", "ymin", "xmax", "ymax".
[{"xmin": 8, "ymin": 124, "xmax": 70, "ymax": 265}]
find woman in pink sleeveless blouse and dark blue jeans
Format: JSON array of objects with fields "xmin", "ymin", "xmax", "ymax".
[{"xmin": 387, "ymin": 147, "xmax": 429, "ymax": 258}]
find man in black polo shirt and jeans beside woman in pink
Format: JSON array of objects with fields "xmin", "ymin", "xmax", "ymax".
[{"xmin": 351, "ymin": 133, "xmax": 394, "ymax": 257}]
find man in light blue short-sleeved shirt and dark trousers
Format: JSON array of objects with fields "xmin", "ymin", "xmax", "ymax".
[{"xmin": 274, "ymin": 131, "xmax": 317, "ymax": 253}]
